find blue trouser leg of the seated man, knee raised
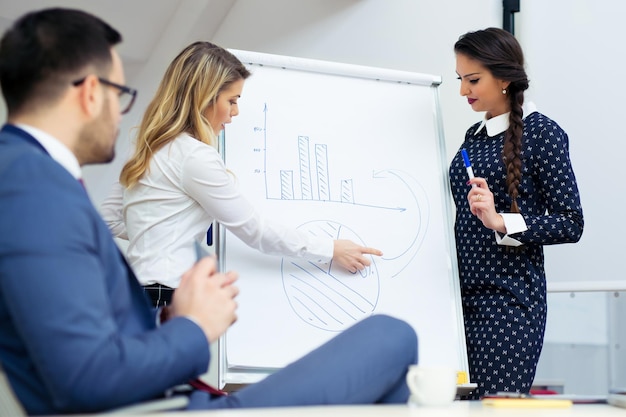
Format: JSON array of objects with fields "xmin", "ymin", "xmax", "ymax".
[{"xmin": 188, "ymin": 315, "xmax": 417, "ymax": 410}]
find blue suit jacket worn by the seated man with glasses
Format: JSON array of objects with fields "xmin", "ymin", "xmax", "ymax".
[{"xmin": 0, "ymin": 125, "xmax": 209, "ymax": 414}]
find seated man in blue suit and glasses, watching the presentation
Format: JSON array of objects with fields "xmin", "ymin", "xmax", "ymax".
[{"xmin": 0, "ymin": 9, "xmax": 417, "ymax": 414}]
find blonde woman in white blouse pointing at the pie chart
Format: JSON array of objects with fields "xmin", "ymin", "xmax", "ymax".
[{"xmin": 102, "ymin": 42, "xmax": 382, "ymax": 306}]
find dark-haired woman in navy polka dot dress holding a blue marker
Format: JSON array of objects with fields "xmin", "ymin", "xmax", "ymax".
[{"xmin": 450, "ymin": 28, "xmax": 583, "ymax": 398}]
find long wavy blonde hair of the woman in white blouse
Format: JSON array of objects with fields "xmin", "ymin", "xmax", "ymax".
[{"xmin": 120, "ymin": 42, "xmax": 250, "ymax": 188}]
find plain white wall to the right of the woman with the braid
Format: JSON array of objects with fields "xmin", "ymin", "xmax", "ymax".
[{"xmin": 519, "ymin": 0, "xmax": 626, "ymax": 281}]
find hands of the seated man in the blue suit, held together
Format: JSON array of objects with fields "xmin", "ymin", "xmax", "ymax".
[{"xmin": 170, "ymin": 256, "xmax": 239, "ymax": 343}]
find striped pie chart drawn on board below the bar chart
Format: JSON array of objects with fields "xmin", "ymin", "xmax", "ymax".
[{"xmin": 281, "ymin": 220, "xmax": 380, "ymax": 332}]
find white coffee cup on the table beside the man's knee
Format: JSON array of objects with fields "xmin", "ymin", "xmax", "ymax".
[{"xmin": 406, "ymin": 365, "xmax": 457, "ymax": 406}]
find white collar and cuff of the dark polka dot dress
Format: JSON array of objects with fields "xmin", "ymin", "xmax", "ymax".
[{"xmin": 474, "ymin": 102, "xmax": 537, "ymax": 246}]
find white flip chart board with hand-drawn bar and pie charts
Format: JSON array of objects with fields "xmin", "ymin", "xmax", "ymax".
[{"xmin": 217, "ymin": 50, "xmax": 467, "ymax": 386}]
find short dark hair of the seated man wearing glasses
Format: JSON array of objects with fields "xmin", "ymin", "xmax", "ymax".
[{"xmin": 0, "ymin": 8, "xmax": 122, "ymax": 115}]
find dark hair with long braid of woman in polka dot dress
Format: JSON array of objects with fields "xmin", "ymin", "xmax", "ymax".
[{"xmin": 454, "ymin": 28, "xmax": 528, "ymax": 213}]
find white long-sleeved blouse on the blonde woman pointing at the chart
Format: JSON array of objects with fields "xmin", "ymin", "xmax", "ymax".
[{"xmin": 101, "ymin": 134, "xmax": 334, "ymax": 288}]
